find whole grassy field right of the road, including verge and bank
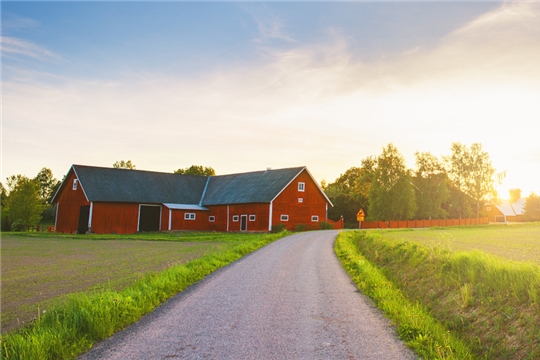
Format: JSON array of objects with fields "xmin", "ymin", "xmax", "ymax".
[{"xmin": 336, "ymin": 223, "xmax": 540, "ymax": 360}]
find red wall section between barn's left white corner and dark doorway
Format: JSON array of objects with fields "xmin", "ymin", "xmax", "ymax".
[{"xmin": 91, "ymin": 202, "xmax": 139, "ymax": 234}]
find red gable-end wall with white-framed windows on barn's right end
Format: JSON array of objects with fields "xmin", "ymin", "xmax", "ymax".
[{"xmin": 272, "ymin": 170, "xmax": 327, "ymax": 230}]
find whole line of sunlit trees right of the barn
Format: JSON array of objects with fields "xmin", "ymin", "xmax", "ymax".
[{"xmin": 321, "ymin": 142, "xmax": 540, "ymax": 225}]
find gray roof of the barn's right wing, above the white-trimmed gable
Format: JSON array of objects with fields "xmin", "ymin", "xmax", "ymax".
[{"xmin": 202, "ymin": 167, "xmax": 305, "ymax": 205}]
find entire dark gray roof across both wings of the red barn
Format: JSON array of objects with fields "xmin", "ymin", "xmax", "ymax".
[{"xmin": 52, "ymin": 165, "xmax": 320, "ymax": 207}]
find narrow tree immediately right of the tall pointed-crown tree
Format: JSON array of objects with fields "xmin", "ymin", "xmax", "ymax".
[{"xmin": 413, "ymin": 152, "xmax": 449, "ymax": 219}]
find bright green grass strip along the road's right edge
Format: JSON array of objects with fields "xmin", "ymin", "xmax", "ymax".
[{"xmin": 334, "ymin": 231, "xmax": 473, "ymax": 360}]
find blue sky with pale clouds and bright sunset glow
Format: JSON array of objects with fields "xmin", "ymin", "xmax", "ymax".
[{"xmin": 0, "ymin": 1, "xmax": 540, "ymax": 198}]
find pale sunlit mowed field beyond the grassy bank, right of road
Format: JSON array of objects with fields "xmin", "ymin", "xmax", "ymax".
[{"xmin": 384, "ymin": 223, "xmax": 540, "ymax": 265}]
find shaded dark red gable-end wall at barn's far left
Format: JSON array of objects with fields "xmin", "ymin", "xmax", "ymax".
[{"xmin": 55, "ymin": 170, "xmax": 90, "ymax": 233}]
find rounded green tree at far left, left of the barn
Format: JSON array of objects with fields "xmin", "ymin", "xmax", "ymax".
[{"xmin": 5, "ymin": 175, "xmax": 45, "ymax": 230}]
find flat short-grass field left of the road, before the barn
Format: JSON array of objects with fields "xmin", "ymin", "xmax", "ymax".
[{"xmin": 1, "ymin": 234, "xmax": 238, "ymax": 333}]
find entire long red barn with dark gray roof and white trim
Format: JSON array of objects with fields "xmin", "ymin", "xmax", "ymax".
[{"xmin": 52, "ymin": 165, "xmax": 333, "ymax": 234}]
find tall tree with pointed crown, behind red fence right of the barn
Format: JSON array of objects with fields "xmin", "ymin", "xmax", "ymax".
[{"xmin": 368, "ymin": 144, "xmax": 416, "ymax": 220}]
